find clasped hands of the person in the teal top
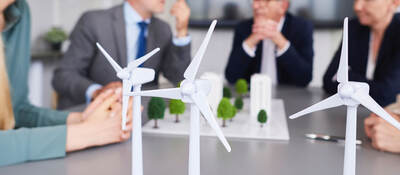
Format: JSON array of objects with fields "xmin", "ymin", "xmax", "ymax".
[{"xmin": 66, "ymin": 91, "xmax": 132, "ymax": 152}]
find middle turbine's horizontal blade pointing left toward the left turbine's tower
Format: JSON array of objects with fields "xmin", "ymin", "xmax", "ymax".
[{"xmin": 129, "ymin": 88, "xmax": 182, "ymax": 100}]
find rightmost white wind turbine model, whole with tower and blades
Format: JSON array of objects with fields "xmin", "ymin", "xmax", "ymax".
[{"xmin": 290, "ymin": 18, "xmax": 400, "ymax": 175}]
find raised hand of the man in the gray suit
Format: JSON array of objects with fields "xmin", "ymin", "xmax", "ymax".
[{"xmin": 170, "ymin": 0, "xmax": 190, "ymax": 38}]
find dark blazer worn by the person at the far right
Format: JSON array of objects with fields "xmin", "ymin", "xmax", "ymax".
[{"xmin": 323, "ymin": 15, "xmax": 400, "ymax": 106}]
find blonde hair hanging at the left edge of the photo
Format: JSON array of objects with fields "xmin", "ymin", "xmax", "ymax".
[{"xmin": 0, "ymin": 35, "xmax": 15, "ymax": 130}]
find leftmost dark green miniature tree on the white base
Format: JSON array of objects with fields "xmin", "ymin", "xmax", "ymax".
[{"xmin": 147, "ymin": 97, "xmax": 165, "ymax": 129}]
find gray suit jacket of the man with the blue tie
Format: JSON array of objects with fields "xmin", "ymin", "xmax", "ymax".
[{"xmin": 52, "ymin": 5, "xmax": 190, "ymax": 109}]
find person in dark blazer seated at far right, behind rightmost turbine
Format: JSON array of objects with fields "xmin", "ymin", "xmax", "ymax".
[{"xmin": 323, "ymin": 0, "xmax": 400, "ymax": 106}]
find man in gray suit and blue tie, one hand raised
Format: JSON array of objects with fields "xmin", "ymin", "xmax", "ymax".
[{"xmin": 52, "ymin": 0, "xmax": 191, "ymax": 109}]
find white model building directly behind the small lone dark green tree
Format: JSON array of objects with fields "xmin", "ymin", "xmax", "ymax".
[{"xmin": 250, "ymin": 74, "xmax": 272, "ymax": 117}]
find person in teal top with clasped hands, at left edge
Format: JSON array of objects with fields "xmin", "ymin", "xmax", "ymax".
[{"xmin": 0, "ymin": 0, "xmax": 132, "ymax": 166}]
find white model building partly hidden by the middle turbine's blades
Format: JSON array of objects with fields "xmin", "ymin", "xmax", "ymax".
[{"xmin": 200, "ymin": 72, "xmax": 224, "ymax": 116}]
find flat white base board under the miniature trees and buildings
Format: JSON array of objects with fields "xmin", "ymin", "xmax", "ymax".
[{"xmin": 143, "ymin": 99, "xmax": 290, "ymax": 140}]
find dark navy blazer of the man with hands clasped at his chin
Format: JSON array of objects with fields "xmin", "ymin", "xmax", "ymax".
[{"xmin": 225, "ymin": 13, "xmax": 314, "ymax": 86}]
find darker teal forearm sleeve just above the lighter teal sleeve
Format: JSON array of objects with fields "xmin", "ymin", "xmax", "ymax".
[{"xmin": 14, "ymin": 102, "xmax": 68, "ymax": 128}]
